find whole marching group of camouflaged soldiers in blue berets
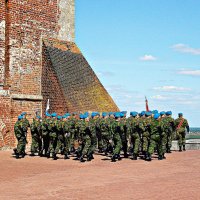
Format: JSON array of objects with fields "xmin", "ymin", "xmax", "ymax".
[{"xmin": 14, "ymin": 110, "xmax": 189, "ymax": 162}]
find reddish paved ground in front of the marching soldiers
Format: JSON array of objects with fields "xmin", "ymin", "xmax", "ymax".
[{"xmin": 0, "ymin": 151, "xmax": 200, "ymax": 200}]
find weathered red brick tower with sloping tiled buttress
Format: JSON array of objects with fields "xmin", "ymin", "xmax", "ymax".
[{"xmin": 0, "ymin": 0, "xmax": 118, "ymax": 148}]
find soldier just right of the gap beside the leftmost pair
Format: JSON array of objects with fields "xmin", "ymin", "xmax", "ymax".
[{"xmin": 30, "ymin": 116, "xmax": 42, "ymax": 156}]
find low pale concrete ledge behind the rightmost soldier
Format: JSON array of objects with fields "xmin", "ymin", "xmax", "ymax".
[{"xmin": 171, "ymin": 139, "xmax": 200, "ymax": 151}]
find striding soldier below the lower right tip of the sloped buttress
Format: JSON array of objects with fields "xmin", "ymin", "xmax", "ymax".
[{"xmin": 111, "ymin": 112, "xmax": 123, "ymax": 162}]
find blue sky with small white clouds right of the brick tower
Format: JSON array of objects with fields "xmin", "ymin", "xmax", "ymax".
[{"xmin": 75, "ymin": 0, "xmax": 200, "ymax": 127}]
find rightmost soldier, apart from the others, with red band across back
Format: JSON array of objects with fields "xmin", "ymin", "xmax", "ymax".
[{"xmin": 175, "ymin": 113, "xmax": 190, "ymax": 151}]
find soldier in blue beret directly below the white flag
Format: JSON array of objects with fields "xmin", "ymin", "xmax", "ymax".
[{"xmin": 41, "ymin": 112, "xmax": 51, "ymax": 157}]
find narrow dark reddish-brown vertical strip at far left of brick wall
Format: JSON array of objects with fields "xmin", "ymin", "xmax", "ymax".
[{"xmin": 4, "ymin": 0, "xmax": 10, "ymax": 89}]
